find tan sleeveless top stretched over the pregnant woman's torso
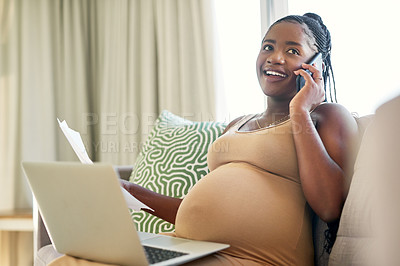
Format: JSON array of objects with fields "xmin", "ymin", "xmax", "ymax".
[{"xmin": 175, "ymin": 115, "xmax": 314, "ymax": 265}]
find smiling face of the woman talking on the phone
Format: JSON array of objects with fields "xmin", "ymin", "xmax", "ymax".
[{"xmin": 257, "ymin": 21, "xmax": 317, "ymax": 98}]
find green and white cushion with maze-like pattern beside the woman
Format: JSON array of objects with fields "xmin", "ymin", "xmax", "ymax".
[{"xmin": 130, "ymin": 111, "xmax": 226, "ymax": 233}]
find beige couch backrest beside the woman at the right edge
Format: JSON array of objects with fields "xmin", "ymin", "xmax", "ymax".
[{"xmin": 329, "ymin": 96, "xmax": 400, "ymax": 266}]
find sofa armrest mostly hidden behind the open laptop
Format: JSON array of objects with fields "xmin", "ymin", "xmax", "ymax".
[{"xmin": 34, "ymin": 165, "xmax": 133, "ymax": 251}]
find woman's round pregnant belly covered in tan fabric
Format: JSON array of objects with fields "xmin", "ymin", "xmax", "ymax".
[{"xmin": 175, "ymin": 163, "xmax": 306, "ymax": 257}]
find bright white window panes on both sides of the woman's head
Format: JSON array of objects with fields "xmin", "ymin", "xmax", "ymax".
[{"xmin": 214, "ymin": 0, "xmax": 400, "ymax": 120}]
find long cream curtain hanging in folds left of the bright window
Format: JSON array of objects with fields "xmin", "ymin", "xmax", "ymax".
[{"xmin": 0, "ymin": 0, "xmax": 215, "ymax": 265}]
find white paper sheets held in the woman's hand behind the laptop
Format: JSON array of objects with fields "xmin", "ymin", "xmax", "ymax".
[{"xmin": 57, "ymin": 118, "xmax": 154, "ymax": 211}]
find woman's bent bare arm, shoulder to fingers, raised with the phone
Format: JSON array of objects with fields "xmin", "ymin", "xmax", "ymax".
[{"xmin": 289, "ymin": 64, "xmax": 358, "ymax": 222}]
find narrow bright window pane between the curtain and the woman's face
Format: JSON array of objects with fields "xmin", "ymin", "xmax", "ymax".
[{"xmin": 214, "ymin": 0, "xmax": 264, "ymax": 121}]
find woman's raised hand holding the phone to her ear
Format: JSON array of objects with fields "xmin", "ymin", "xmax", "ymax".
[{"xmin": 289, "ymin": 64, "xmax": 325, "ymax": 112}]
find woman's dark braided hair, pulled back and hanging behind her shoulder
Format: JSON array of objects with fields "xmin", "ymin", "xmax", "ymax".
[{"xmin": 270, "ymin": 13, "xmax": 337, "ymax": 102}]
